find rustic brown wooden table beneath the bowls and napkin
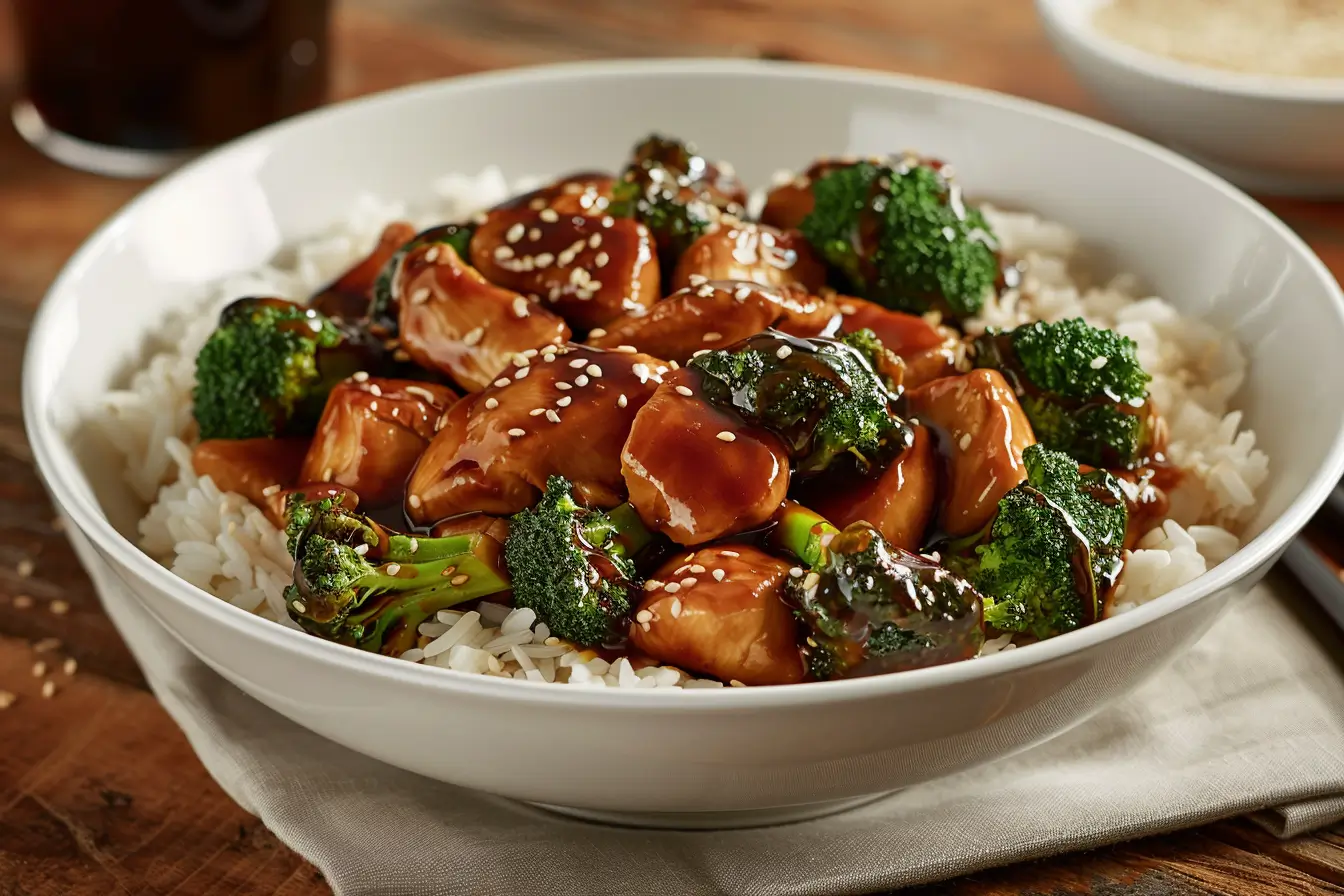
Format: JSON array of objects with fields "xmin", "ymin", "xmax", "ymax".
[{"xmin": 0, "ymin": 0, "xmax": 1344, "ymax": 896}]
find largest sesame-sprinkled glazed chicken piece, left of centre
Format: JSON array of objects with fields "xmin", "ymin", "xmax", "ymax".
[{"xmin": 406, "ymin": 345, "xmax": 668, "ymax": 525}]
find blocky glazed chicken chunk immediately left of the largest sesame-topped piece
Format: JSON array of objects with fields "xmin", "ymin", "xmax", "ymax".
[{"xmin": 300, "ymin": 376, "xmax": 457, "ymax": 508}]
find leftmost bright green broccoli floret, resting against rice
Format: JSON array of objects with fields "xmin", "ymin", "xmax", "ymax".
[{"xmin": 192, "ymin": 298, "xmax": 367, "ymax": 439}]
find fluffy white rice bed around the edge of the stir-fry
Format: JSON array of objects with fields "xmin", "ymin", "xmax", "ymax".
[{"xmin": 102, "ymin": 168, "xmax": 1269, "ymax": 679}]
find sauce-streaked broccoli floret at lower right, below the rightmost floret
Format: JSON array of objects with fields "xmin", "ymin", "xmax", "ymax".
[{"xmin": 948, "ymin": 445, "xmax": 1129, "ymax": 638}]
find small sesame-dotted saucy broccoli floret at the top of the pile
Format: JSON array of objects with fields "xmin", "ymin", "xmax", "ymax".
[{"xmin": 607, "ymin": 134, "xmax": 745, "ymax": 265}]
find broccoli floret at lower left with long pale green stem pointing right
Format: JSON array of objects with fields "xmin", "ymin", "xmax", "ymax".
[{"xmin": 285, "ymin": 500, "xmax": 509, "ymax": 656}]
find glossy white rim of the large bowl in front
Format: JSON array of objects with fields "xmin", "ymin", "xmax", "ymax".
[{"xmin": 23, "ymin": 59, "xmax": 1344, "ymax": 712}]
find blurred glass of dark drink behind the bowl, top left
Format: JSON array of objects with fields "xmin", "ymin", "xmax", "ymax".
[{"xmin": 12, "ymin": 0, "xmax": 331, "ymax": 177}]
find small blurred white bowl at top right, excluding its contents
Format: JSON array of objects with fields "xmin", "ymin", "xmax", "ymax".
[{"xmin": 1036, "ymin": 0, "xmax": 1344, "ymax": 196}]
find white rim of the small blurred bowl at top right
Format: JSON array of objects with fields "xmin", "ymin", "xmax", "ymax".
[{"xmin": 1035, "ymin": 0, "xmax": 1344, "ymax": 106}]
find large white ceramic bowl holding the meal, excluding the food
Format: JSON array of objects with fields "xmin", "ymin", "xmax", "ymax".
[{"xmin": 24, "ymin": 60, "xmax": 1344, "ymax": 825}]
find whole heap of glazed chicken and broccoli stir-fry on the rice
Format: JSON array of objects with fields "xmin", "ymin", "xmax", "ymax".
[{"xmin": 184, "ymin": 137, "xmax": 1167, "ymax": 685}]
